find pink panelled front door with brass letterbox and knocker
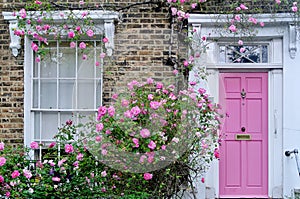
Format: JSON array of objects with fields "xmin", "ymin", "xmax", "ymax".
[{"xmin": 219, "ymin": 73, "xmax": 268, "ymax": 198}]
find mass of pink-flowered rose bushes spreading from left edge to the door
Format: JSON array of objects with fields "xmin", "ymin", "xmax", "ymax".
[{"xmin": 0, "ymin": 79, "xmax": 219, "ymax": 198}]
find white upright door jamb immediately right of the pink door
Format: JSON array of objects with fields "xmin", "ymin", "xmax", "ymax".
[{"xmin": 268, "ymin": 69, "xmax": 283, "ymax": 198}]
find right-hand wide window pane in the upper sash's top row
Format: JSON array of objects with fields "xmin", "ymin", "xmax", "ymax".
[{"xmin": 78, "ymin": 50, "xmax": 95, "ymax": 78}]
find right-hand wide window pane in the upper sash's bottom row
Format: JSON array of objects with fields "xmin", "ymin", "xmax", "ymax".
[{"xmin": 78, "ymin": 80, "xmax": 95, "ymax": 109}]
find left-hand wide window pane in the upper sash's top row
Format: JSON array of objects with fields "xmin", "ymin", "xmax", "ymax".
[{"xmin": 40, "ymin": 52, "xmax": 57, "ymax": 77}]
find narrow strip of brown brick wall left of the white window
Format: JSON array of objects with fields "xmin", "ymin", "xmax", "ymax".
[{"xmin": 0, "ymin": 1, "xmax": 24, "ymax": 144}]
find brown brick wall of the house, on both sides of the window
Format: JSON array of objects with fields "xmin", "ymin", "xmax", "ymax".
[{"xmin": 0, "ymin": 0, "xmax": 182, "ymax": 144}]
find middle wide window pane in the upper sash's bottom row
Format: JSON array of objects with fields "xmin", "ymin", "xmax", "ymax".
[{"xmin": 58, "ymin": 80, "xmax": 76, "ymax": 109}]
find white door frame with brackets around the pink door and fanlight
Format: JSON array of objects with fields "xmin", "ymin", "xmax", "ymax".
[{"xmin": 189, "ymin": 14, "xmax": 288, "ymax": 198}]
